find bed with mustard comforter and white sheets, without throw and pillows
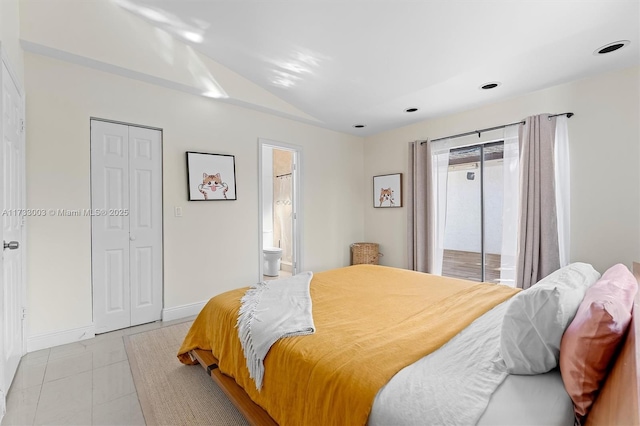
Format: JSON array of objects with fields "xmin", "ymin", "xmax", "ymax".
[{"xmin": 179, "ymin": 265, "xmax": 640, "ymax": 426}]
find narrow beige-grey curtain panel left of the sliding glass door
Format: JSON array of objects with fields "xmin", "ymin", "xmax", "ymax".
[{"xmin": 407, "ymin": 141, "xmax": 433, "ymax": 272}]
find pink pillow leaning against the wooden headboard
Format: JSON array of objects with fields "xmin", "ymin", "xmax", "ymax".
[{"xmin": 560, "ymin": 264, "xmax": 638, "ymax": 419}]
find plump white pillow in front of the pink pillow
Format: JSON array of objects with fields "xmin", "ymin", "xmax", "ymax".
[{"xmin": 500, "ymin": 263, "xmax": 600, "ymax": 374}]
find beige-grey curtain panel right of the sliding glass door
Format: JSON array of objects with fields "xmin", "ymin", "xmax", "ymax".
[{"xmin": 516, "ymin": 114, "xmax": 560, "ymax": 289}]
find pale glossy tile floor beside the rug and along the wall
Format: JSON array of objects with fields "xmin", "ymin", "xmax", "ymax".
[{"xmin": 2, "ymin": 318, "xmax": 193, "ymax": 426}]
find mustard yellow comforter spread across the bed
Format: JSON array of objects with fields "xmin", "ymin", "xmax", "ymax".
[{"xmin": 178, "ymin": 265, "xmax": 518, "ymax": 426}]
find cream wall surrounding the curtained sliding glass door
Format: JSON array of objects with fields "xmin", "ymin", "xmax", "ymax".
[{"xmin": 364, "ymin": 67, "xmax": 640, "ymax": 272}]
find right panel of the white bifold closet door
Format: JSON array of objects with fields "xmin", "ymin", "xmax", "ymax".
[{"xmin": 129, "ymin": 127, "xmax": 162, "ymax": 325}]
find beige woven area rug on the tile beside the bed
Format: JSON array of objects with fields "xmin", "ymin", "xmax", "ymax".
[{"xmin": 125, "ymin": 321, "xmax": 248, "ymax": 426}]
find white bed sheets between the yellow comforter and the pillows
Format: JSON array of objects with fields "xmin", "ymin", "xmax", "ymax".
[{"xmin": 368, "ymin": 301, "xmax": 573, "ymax": 426}]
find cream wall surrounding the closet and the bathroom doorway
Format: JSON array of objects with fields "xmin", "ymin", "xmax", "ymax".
[{"xmin": 25, "ymin": 53, "xmax": 368, "ymax": 336}]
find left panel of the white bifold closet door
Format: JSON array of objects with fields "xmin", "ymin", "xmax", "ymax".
[{"xmin": 91, "ymin": 120, "xmax": 131, "ymax": 333}]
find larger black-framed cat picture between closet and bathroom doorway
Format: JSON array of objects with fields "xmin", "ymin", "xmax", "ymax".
[{"xmin": 187, "ymin": 152, "xmax": 237, "ymax": 201}]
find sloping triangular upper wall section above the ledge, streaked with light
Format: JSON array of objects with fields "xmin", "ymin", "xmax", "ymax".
[{"xmin": 20, "ymin": 0, "xmax": 318, "ymax": 123}]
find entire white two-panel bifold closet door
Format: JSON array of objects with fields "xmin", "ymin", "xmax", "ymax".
[{"xmin": 91, "ymin": 120, "xmax": 162, "ymax": 333}]
